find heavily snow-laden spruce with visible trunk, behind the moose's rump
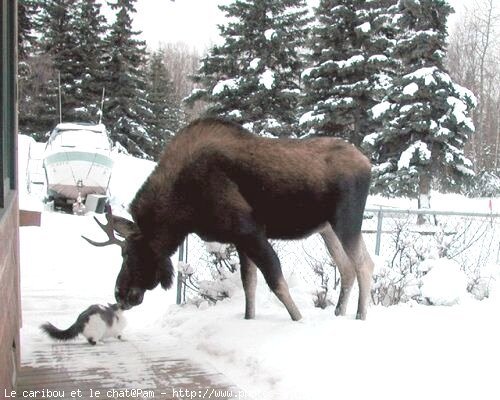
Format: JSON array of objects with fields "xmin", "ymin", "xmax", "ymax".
[{"xmin": 364, "ymin": 0, "xmax": 475, "ymax": 207}]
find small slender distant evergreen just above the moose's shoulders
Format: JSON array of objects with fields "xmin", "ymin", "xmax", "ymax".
[{"xmin": 147, "ymin": 50, "xmax": 185, "ymax": 160}]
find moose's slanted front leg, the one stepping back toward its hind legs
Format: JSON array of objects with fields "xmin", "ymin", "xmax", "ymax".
[{"xmin": 237, "ymin": 233, "xmax": 302, "ymax": 321}]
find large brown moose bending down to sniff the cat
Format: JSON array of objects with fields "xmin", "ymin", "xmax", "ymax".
[{"xmin": 85, "ymin": 118, "xmax": 373, "ymax": 321}]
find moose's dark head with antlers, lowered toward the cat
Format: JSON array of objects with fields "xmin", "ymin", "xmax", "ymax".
[{"xmin": 83, "ymin": 205, "xmax": 173, "ymax": 309}]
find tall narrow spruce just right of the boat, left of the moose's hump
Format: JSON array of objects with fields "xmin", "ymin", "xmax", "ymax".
[{"xmin": 103, "ymin": 0, "xmax": 155, "ymax": 158}]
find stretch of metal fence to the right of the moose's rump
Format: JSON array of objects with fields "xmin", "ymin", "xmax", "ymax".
[{"xmin": 363, "ymin": 207, "xmax": 500, "ymax": 269}]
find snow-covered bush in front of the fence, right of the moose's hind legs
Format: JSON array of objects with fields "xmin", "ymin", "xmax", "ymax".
[{"xmin": 372, "ymin": 217, "xmax": 484, "ymax": 306}]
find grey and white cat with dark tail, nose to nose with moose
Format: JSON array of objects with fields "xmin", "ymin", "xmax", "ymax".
[{"xmin": 40, "ymin": 304, "xmax": 127, "ymax": 345}]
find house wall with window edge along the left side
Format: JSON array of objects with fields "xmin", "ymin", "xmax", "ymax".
[{"xmin": 0, "ymin": 0, "xmax": 21, "ymax": 390}]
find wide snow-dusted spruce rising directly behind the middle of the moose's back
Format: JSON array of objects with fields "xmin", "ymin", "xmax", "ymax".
[{"xmin": 186, "ymin": 0, "xmax": 309, "ymax": 136}]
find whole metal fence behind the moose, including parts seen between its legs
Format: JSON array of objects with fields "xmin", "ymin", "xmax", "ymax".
[{"xmin": 177, "ymin": 207, "xmax": 500, "ymax": 303}]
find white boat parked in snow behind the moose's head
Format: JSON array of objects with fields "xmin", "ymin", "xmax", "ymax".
[{"xmin": 43, "ymin": 123, "xmax": 113, "ymax": 204}]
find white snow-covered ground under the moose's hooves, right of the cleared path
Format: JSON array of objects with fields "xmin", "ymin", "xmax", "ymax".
[{"xmin": 155, "ymin": 288, "xmax": 500, "ymax": 400}]
